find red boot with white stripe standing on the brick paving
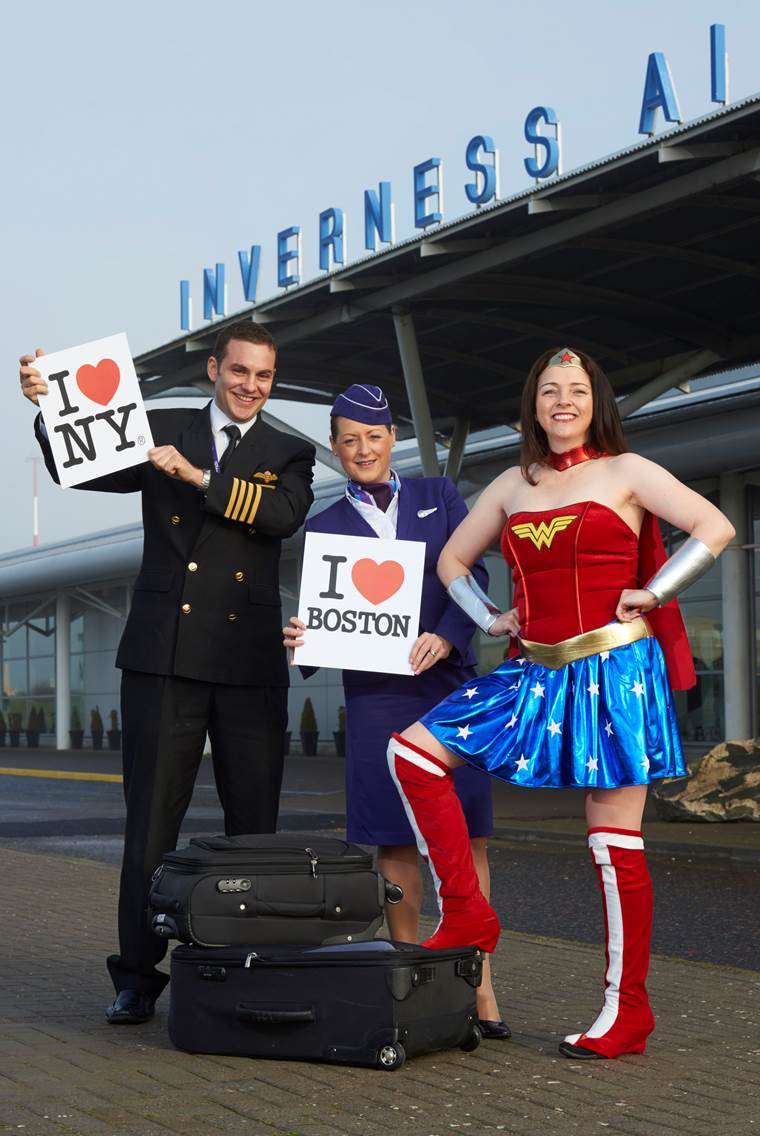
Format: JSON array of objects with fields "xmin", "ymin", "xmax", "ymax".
[{"xmin": 560, "ymin": 828, "xmax": 654, "ymax": 1059}]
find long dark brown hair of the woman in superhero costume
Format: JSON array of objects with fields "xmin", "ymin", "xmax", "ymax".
[{"xmin": 520, "ymin": 348, "xmax": 628, "ymax": 485}]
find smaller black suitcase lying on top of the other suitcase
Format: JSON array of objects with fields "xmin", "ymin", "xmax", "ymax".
[{"xmin": 149, "ymin": 833, "xmax": 402, "ymax": 947}]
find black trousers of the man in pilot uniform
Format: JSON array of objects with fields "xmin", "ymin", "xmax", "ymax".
[{"xmin": 108, "ymin": 670, "xmax": 287, "ymax": 997}]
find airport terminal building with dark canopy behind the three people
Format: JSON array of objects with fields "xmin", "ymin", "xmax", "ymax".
[{"xmin": 0, "ymin": 99, "xmax": 760, "ymax": 755}]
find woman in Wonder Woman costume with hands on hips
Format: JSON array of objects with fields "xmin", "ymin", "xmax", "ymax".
[{"xmin": 389, "ymin": 348, "xmax": 734, "ymax": 1060}]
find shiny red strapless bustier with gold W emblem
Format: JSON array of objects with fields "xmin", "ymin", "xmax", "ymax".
[{"xmin": 501, "ymin": 501, "xmax": 638, "ymax": 643}]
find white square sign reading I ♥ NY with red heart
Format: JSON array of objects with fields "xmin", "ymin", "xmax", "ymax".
[{"xmin": 34, "ymin": 334, "xmax": 153, "ymax": 485}]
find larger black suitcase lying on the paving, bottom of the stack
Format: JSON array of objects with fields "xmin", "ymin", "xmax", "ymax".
[{"xmin": 169, "ymin": 939, "xmax": 482, "ymax": 1069}]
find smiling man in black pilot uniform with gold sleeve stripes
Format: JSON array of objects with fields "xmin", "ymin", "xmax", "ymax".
[{"xmin": 20, "ymin": 321, "xmax": 315, "ymax": 1025}]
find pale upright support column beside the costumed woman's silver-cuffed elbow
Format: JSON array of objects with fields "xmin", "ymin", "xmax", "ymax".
[{"xmin": 719, "ymin": 474, "xmax": 752, "ymax": 740}]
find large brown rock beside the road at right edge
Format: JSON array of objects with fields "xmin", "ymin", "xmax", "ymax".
[{"xmin": 653, "ymin": 741, "xmax": 760, "ymax": 821}]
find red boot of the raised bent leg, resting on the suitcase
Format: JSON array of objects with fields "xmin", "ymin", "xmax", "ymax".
[{"xmin": 387, "ymin": 734, "xmax": 499, "ymax": 952}]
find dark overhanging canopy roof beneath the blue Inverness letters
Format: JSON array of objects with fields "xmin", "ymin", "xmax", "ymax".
[{"xmin": 136, "ymin": 95, "xmax": 760, "ymax": 433}]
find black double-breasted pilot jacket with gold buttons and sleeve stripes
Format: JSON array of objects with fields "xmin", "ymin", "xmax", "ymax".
[{"xmin": 35, "ymin": 406, "xmax": 315, "ymax": 686}]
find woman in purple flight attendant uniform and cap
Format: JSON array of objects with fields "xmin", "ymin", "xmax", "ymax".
[{"xmin": 283, "ymin": 384, "xmax": 510, "ymax": 1039}]
